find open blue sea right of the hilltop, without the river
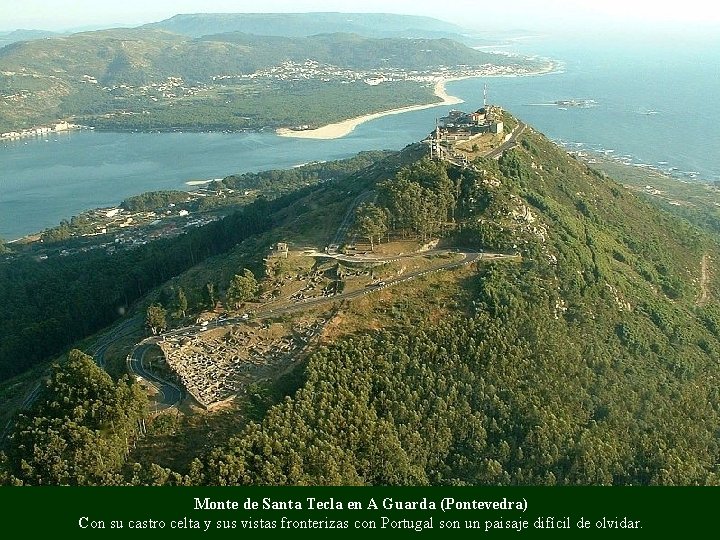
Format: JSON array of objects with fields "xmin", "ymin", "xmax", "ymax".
[{"xmin": 466, "ymin": 34, "xmax": 720, "ymax": 181}]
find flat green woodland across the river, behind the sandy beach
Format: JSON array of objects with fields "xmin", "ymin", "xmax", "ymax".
[{"xmin": 79, "ymin": 81, "xmax": 438, "ymax": 131}]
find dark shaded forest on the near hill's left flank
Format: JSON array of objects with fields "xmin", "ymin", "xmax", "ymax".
[{"xmin": 0, "ymin": 201, "xmax": 268, "ymax": 379}]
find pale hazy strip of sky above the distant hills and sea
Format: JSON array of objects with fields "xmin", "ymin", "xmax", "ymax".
[{"xmin": 0, "ymin": 0, "xmax": 720, "ymax": 31}]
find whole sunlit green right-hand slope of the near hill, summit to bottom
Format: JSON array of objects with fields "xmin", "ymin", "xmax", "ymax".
[{"xmin": 0, "ymin": 122, "xmax": 720, "ymax": 485}]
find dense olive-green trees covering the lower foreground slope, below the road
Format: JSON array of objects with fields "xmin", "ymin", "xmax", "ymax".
[{"xmin": 204, "ymin": 296, "xmax": 720, "ymax": 485}]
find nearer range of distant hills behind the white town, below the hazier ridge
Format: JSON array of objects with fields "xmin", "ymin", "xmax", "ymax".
[{"xmin": 0, "ymin": 24, "xmax": 506, "ymax": 84}]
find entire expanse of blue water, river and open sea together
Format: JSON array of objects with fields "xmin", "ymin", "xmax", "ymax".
[{"xmin": 0, "ymin": 31, "xmax": 720, "ymax": 240}]
